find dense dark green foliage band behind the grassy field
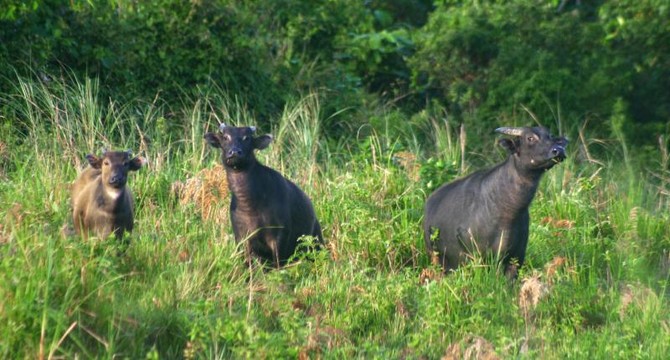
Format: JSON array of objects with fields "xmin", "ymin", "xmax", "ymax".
[{"xmin": 0, "ymin": 0, "xmax": 670, "ymax": 143}]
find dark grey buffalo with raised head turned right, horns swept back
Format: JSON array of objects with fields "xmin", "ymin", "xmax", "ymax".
[{"xmin": 424, "ymin": 127, "xmax": 567, "ymax": 276}]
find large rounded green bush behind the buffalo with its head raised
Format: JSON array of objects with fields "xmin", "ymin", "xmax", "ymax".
[{"xmin": 409, "ymin": 0, "xmax": 670, "ymax": 141}]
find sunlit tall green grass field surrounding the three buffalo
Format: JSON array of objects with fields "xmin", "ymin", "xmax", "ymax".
[{"xmin": 0, "ymin": 80, "xmax": 670, "ymax": 359}]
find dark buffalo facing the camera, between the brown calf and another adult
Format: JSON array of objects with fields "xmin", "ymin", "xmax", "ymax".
[{"xmin": 205, "ymin": 125, "xmax": 323, "ymax": 267}]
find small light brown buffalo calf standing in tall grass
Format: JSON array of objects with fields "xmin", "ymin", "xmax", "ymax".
[{"xmin": 72, "ymin": 151, "xmax": 145, "ymax": 240}]
